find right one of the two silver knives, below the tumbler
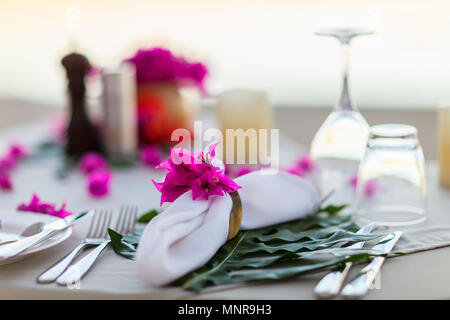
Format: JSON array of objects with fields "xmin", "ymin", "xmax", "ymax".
[{"xmin": 341, "ymin": 231, "xmax": 402, "ymax": 299}]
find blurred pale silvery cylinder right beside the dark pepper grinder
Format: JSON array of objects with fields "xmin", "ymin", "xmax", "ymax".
[{"xmin": 103, "ymin": 63, "xmax": 138, "ymax": 158}]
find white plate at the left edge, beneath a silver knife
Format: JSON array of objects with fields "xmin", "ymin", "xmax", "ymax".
[{"xmin": 0, "ymin": 211, "xmax": 72, "ymax": 265}]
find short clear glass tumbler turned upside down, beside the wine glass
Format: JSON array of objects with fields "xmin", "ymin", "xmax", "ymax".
[{"xmin": 356, "ymin": 124, "xmax": 427, "ymax": 226}]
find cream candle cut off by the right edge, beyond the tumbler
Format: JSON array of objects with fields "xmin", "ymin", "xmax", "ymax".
[{"xmin": 438, "ymin": 106, "xmax": 450, "ymax": 187}]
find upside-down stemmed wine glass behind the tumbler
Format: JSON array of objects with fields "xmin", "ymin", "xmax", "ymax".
[{"xmin": 310, "ymin": 29, "xmax": 373, "ymax": 204}]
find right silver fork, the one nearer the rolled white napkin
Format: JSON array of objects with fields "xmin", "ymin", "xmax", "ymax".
[{"xmin": 56, "ymin": 206, "xmax": 137, "ymax": 286}]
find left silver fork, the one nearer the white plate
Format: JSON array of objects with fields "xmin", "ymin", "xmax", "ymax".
[{"xmin": 37, "ymin": 210, "xmax": 112, "ymax": 283}]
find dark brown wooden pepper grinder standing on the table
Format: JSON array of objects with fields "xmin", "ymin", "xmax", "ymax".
[{"xmin": 61, "ymin": 53, "xmax": 102, "ymax": 157}]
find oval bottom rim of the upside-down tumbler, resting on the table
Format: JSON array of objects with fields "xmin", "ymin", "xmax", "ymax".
[{"xmin": 356, "ymin": 205, "xmax": 427, "ymax": 226}]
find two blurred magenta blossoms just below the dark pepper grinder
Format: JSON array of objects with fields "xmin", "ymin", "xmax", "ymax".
[{"xmin": 79, "ymin": 152, "xmax": 113, "ymax": 198}]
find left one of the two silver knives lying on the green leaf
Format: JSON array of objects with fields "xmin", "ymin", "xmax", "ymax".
[{"xmin": 314, "ymin": 224, "xmax": 373, "ymax": 299}]
